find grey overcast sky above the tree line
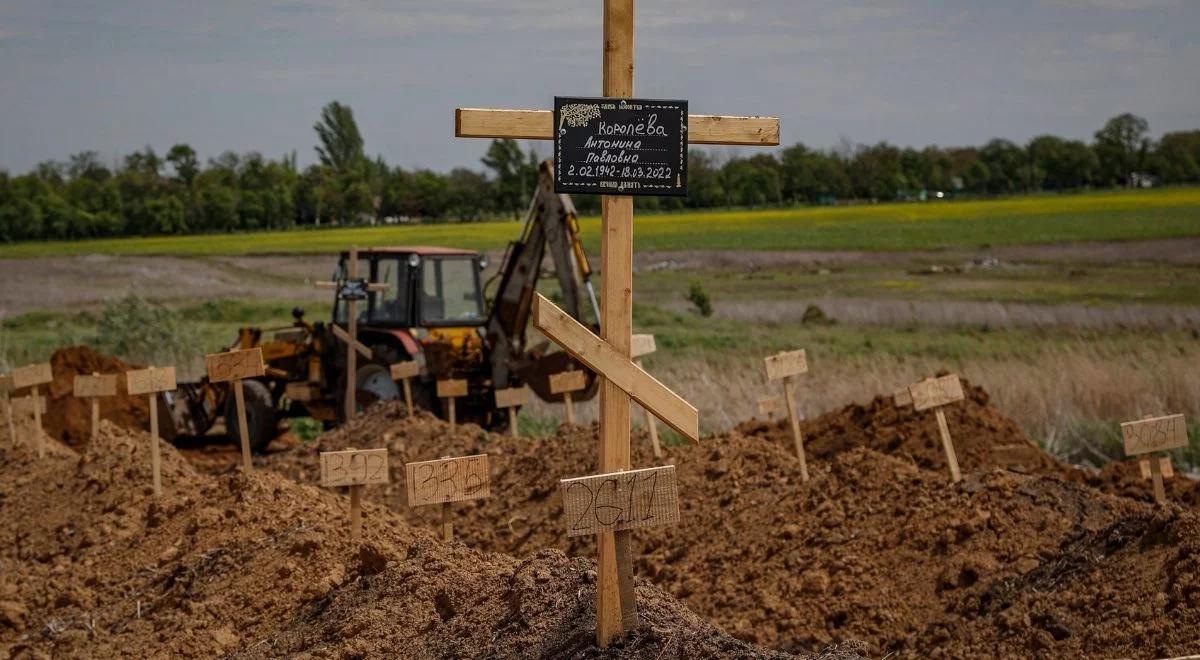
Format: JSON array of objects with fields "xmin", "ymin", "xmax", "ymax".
[{"xmin": 0, "ymin": 0, "xmax": 1200, "ymax": 170}]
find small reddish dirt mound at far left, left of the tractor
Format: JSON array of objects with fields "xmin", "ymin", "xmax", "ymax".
[{"xmin": 42, "ymin": 346, "xmax": 150, "ymax": 449}]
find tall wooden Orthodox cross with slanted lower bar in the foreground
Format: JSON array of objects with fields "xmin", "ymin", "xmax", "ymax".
[{"xmin": 455, "ymin": 0, "xmax": 779, "ymax": 646}]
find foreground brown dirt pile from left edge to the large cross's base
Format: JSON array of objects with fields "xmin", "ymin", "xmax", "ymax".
[{"xmin": 0, "ymin": 422, "xmax": 835, "ymax": 658}]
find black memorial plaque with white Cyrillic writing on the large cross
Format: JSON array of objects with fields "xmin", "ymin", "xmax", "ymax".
[{"xmin": 554, "ymin": 96, "xmax": 688, "ymax": 196}]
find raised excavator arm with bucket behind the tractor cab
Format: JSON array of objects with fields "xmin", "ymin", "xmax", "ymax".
[{"xmin": 487, "ymin": 160, "xmax": 600, "ymax": 401}]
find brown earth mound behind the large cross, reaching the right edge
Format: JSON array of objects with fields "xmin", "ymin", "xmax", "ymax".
[{"xmin": 266, "ymin": 400, "xmax": 1200, "ymax": 658}]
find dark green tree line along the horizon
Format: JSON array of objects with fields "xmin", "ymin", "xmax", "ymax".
[{"xmin": 0, "ymin": 102, "xmax": 1200, "ymax": 241}]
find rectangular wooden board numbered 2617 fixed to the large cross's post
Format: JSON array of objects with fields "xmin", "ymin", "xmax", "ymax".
[{"xmin": 559, "ymin": 466, "xmax": 679, "ymax": 536}]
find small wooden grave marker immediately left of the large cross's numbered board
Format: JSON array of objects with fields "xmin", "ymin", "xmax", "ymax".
[{"xmin": 404, "ymin": 454, "xmax": 492, "ymax": 542}]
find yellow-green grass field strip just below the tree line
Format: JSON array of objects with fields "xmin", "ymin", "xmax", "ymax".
[{"xmin": 0, "ymin": 188, "xmax": 1200, "ymax": 258}]
